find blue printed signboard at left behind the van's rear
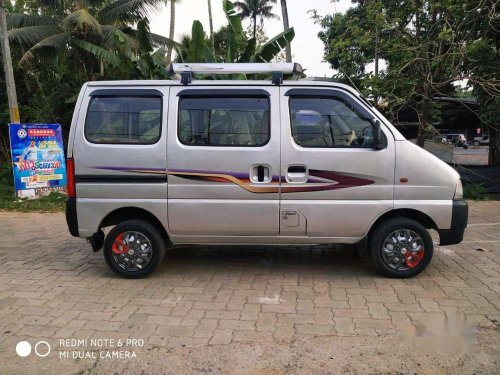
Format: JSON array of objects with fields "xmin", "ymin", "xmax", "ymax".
[{"xmin": 9, "ymin": 124, "xmax": 66, "ymax": 198}]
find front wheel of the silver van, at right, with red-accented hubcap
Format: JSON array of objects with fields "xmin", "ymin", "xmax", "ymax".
[{"xmin": 369, "ymin": 218, "xmax": 434, "ymax": 278}]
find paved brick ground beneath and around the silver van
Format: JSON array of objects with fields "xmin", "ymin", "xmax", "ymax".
[{"xmin": 0, "ymin": 202, "xmax": 500, "ymax": 374}]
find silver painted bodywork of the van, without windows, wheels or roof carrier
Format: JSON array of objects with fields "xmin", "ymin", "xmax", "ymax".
[{"xmin": 68, "ymin": 81, "xmax": 459, "ymax": 245}]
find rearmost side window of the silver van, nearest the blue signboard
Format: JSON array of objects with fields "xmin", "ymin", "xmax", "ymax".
[{"xmin": 85, "ymin": 96, "xmax": 162, "ymax": 144}]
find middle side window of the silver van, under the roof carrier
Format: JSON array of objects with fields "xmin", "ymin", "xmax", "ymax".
[{"xmin": 178, "ymin": 97, "xmax": 270, "ymax": 147}]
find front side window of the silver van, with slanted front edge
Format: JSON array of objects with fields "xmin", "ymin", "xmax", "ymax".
[{"xmin": 290, "ymin": 97, "xmax": 373, "ymax": 148}]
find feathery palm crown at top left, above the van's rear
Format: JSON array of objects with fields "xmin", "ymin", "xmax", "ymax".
[{"xmin": 7, "ymin": 0, "xmax": 171, "ymax": 80}]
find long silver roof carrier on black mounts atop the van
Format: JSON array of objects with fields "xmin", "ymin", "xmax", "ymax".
[{"xmin": 170, "ymin": 63, "xmax": 303, "ymax": 85}]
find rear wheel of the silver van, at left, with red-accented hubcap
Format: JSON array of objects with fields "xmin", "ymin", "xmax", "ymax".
[{"xmin": 104, "ymin": 220, "xmax": 165, "ymax": 279}]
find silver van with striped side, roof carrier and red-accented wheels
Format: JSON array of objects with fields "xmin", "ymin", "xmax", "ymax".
[{"xmin": 66, "ymin": 64, "xmax": 468, "ymax": 278}]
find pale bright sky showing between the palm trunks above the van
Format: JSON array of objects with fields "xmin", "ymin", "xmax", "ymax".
[{"xmin": 147, "ymin": 0, "xmax": 351, "ymax": 77}]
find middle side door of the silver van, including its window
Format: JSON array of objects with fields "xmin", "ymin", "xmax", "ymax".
[{"xmin": 167, "ymin": 86, "xmax": 280, "ymax": 242}]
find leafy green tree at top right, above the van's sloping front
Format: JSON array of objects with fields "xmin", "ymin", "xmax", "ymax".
[{"xmin": 314, "ymin": 0, "xmax": 500, "ymax": 153}]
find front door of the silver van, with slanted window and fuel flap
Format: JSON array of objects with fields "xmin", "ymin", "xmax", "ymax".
[{"xmin": 280, "ymin": 86, "xmax": 395, "ymax": 242}]
